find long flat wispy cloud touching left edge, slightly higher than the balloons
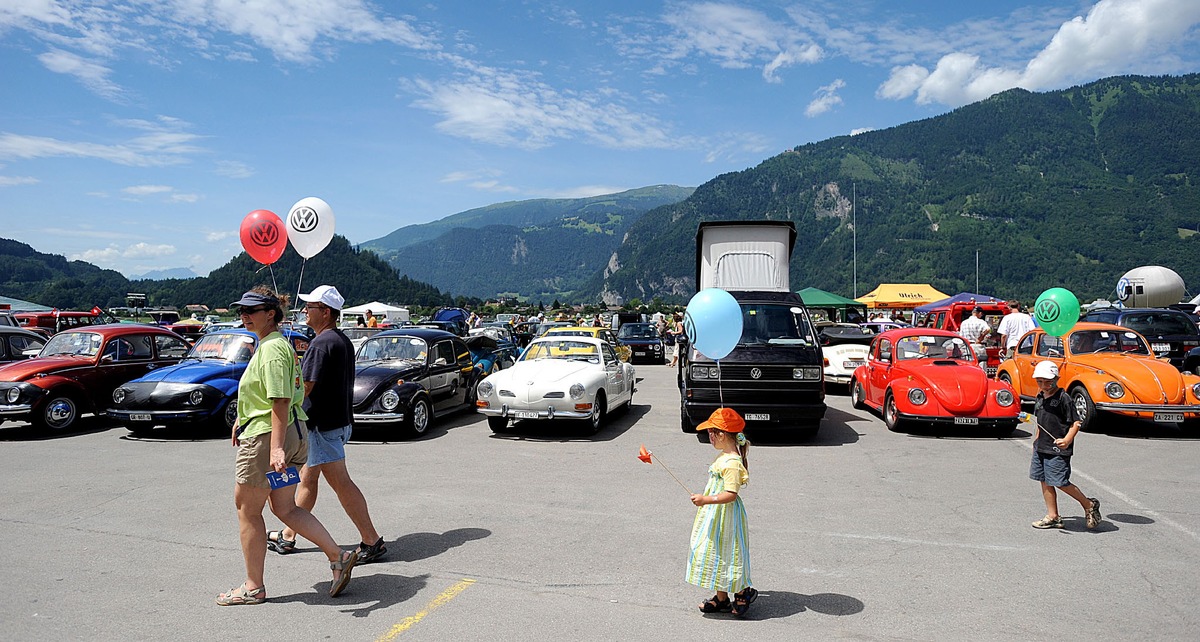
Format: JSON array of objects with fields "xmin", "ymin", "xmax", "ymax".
[{"xmin": 0, "ymin": 116, "xmax": 202, "ymax": 167}]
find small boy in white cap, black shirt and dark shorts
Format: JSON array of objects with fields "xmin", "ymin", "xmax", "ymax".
[{"xmin": 1030, "ymin": 361, "xmax": 1100, "ymax": 529}]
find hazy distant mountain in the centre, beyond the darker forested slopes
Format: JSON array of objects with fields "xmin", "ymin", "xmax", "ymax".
[{"xmin": 361, "ymin": 185, "xmax": 694, "ymax": 301}]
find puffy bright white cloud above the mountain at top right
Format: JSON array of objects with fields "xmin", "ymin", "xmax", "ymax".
[{"xmin": 876, "ymin": 0, "xmax": 1200, "ymax": 106}]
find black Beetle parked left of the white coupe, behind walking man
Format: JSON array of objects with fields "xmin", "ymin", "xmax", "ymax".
[{"xmin": 353, "ymin": 328, "xmax": 476, "ymax": 437}]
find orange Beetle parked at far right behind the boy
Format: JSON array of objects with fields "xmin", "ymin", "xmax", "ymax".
[{"xmin": 996, "ymin": 323, "xmax": 1200, "ymax": 428}]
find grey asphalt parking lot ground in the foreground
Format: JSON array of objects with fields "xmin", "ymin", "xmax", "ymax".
[{"xmin": 0, "ymin": 366, "xmax": 1200, "ymax": 641}]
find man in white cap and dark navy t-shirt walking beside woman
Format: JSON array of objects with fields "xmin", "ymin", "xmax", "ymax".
[{"xmin": 266, "ymin": 286, "xmax": 388, "ymax": 564}]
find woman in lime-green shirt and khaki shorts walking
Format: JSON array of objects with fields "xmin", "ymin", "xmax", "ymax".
[{"xmin": 217, "ymin": 286, "xmax": 359, "ymax": 606}]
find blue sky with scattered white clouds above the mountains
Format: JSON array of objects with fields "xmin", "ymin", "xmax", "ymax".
[{"xmin": 0, "ymin": 0, "xmax": 1200, "ymax": 275}]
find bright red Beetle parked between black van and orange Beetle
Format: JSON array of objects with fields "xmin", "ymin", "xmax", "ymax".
[{"xmin": 851, "ymin": 328, "xmax": 1021, "ymax": 434}]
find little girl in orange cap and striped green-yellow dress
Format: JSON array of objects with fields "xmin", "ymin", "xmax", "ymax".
[{"xmin": 686, "ymin": 408, "xmax": 758, "ymax": 617}]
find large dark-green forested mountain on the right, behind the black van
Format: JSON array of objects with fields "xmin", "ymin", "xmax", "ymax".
[{"xmin": 597, "ymin": 74, "xmax": 1200, "ymax": 301}]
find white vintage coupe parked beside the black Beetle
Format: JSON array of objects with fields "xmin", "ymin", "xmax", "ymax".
[{"xmin": 475, "ymin": 336, "xmax": 635, "ymax": 432}]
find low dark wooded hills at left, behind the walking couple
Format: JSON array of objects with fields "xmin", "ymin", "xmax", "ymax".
[{"xmin": 0, "ymin": 236, "xmax": 452, "ymax": 310}]
